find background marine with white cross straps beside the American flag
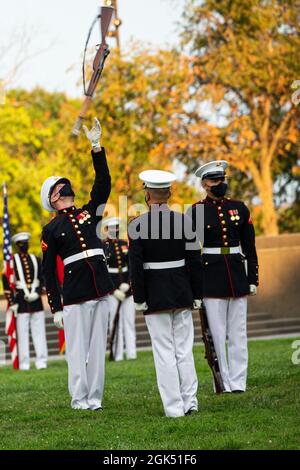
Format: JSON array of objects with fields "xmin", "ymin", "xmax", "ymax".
[{"xmin": 3, "ymin": 232, "xmax": 48, "ymax": 370}]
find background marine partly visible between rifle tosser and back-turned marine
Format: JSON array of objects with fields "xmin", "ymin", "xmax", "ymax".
[{"xmin": 104, "ymin": 217, "xmax": 136, "ymax": 361}]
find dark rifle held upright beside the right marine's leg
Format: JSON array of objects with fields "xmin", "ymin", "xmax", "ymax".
[{"xmin": 199, "ymin": 302, "xmax": 225, "ymax": 393}]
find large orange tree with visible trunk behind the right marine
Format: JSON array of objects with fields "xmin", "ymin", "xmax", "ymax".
[{"xmin": 174, "ymin": 0, "xmax": 300, "ymax": 235}]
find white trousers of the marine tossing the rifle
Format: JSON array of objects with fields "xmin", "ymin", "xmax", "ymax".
[{"xmin": 63, "ymin": 296, "xmax": 108, "ymax": 410}]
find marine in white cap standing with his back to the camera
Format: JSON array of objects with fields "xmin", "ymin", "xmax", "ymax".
[{"xmin": 128, "ymin": 170, "xmax": 202, "ymax": 417}]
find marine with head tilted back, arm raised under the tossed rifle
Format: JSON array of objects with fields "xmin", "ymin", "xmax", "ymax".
[{"xmin": 41, "ymin": 119, "xmax": 113, "ymax": 410}]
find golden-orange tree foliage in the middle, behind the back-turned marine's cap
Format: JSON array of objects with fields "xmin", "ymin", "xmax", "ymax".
[{"xmin": 85, "ymin": 45, "xmax": 194, "ymax": 207}]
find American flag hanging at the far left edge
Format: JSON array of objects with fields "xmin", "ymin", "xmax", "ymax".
[{"xmin": 3, "ymin": 183, "xmax": 19, "ymax": 369}]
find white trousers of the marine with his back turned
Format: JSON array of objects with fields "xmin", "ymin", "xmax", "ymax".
[{"xmin": 145, "ymin": 310, "xmax": 198, "ymax": 418}]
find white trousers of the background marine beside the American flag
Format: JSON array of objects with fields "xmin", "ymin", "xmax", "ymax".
[{"xmin": 17, "ymin": 311, "xmax": 48, "ymax": 370}]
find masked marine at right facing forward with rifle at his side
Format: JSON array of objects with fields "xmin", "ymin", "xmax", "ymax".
[{"xmin": 188, "ymin": 160, "xmax": 258, "ymax": 393}]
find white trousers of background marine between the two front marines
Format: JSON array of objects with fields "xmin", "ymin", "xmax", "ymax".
[{"xmin": 108, "ymin": 295, "xmax": 136, "ymax": 361}]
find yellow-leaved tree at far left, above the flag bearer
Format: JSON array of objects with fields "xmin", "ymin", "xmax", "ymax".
[{"xmin": 0, "ymin": 89, "xmax": 73, "ymax": 253}]
